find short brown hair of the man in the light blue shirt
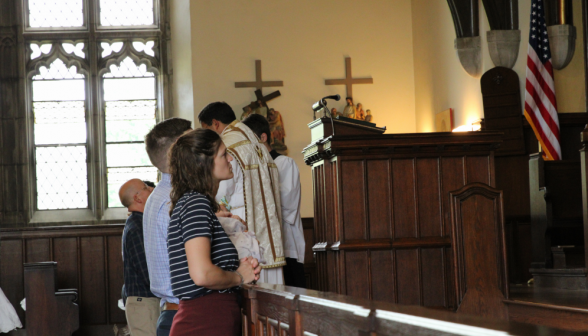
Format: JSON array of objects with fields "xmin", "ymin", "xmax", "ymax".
[{"xmin": 145, "ymin": 118, "xmax": 192, "ymax": 170}]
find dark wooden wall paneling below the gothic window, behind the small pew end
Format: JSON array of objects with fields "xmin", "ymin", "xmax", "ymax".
[{"xmin": 0, "ymin": 224, "xmax": 126, "ymax": 328}]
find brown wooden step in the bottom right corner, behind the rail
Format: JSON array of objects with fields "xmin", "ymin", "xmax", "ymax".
[{"xmin": 504, "ymin": 286, "xmax": 588, "ymax": 331}]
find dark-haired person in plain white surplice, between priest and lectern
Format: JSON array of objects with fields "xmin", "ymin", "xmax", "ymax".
[{"xmin": 243, "ymin": 114, "xmax": 306, "ymax": 288}]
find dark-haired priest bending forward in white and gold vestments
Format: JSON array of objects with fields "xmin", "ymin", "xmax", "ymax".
[{"xmin": 198, "ymin": 102, "xmax": 286, "ymax": 284}]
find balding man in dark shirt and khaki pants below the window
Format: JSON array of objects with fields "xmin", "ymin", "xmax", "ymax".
[{"xmin": 119, "ymin": 179, "xmax": 159, "ymax": 336}]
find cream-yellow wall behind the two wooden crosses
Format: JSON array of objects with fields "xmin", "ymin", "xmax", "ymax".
[{"xmin": 187, "ymin": 0, "xmax": 414, "ymax": 217}]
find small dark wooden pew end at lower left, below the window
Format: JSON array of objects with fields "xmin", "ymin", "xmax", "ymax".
[{"xmin": 24, "ymin": 262, "xmax": 80, "ymax": 336}]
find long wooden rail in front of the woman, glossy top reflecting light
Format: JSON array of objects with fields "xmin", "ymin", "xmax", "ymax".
[{"xmin": 242, "ymin": 284, "xmax": 585, "ymax": 336}]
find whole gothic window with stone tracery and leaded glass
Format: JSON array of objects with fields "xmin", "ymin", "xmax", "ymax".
[{"xmin": 17, "ymin": 0, "xmax": 171, "ymax": 223}]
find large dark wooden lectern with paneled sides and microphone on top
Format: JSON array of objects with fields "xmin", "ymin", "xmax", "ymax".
[{"xmin": 303, "ymin": 118, "xmax": 508, "ymax": 318}]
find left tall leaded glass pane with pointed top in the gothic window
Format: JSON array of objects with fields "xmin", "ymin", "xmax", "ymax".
[{"xmin": 32, "ymin": 59, "xmax": 88, "ymax": 210}]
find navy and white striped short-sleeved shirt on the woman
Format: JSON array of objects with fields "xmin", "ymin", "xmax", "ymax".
[{"xmin": 167, "ymin": 191, "xmax": 239, "ymax": 300}]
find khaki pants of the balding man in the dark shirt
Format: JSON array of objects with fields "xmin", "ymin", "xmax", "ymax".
[{"xmin": 125, "ymin": 296, "xmax": 160, "ymax": 336}]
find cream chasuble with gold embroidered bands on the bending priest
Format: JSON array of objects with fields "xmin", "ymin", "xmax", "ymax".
[{"xmin": 221, "ymin": 120, "xmax": 286, "ymax": 268}]
